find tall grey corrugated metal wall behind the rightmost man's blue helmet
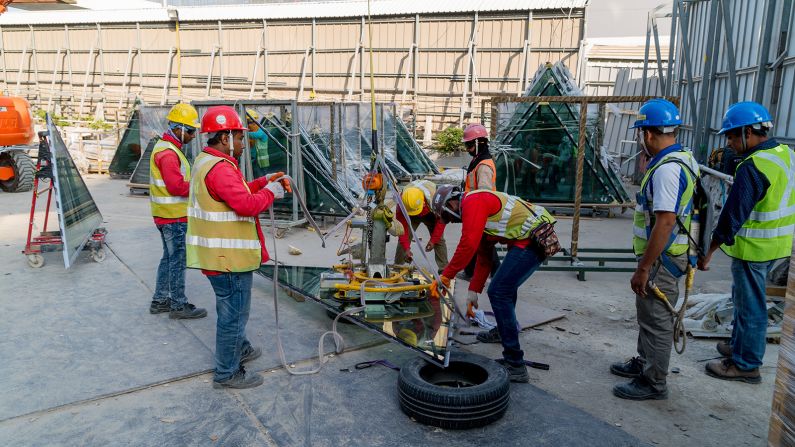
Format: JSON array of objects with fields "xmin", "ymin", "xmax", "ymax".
[{"xmin": 675, "ymin": 0, "xmax": 795, "ymax": 161}]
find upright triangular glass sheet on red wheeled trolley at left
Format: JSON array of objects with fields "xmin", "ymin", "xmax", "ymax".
[{"xmin": 47, "ymin": 115, "xmax": 102, "ymax": 268}]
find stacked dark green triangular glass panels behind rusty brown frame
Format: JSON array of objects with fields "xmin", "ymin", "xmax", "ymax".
[{"xmin": 492, "ymin": 63, "xmax": 630, "ymax": 204}]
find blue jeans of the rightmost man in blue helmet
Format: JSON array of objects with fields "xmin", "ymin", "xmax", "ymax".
[{"xmin": 731, "ymin": 259, "xmax": 773, "ymax": 371}]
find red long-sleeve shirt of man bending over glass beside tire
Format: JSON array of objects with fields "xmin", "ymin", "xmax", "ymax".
[{"xmin": 442, "ymin": 194, "xmax": 530, "ymax": 293}]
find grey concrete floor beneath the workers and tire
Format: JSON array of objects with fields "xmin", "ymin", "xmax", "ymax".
[{"xmin": 0, "ymin": 176, "xmax": 778, "ymax": 446}]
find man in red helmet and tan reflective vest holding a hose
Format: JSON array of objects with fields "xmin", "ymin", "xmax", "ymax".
[{"xmin": 187, "ymin": 106, "xmax": 286, "ymax": 388}]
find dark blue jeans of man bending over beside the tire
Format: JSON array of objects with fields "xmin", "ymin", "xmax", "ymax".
[{"xmin": 488, "ymin": 247, "xmax": 543, "ymax": 366}]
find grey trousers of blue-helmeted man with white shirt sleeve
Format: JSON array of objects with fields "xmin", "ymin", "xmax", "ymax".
[{"xmin": 635, "ymin": 255, "xmax": 687, "ymax": 392}]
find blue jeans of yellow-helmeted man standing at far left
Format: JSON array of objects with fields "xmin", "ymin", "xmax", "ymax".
[{"xmin": 152, "ymin": 222, "xmax": 188, "ymax": 309}]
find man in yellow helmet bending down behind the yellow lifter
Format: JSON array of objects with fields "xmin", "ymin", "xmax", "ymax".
[{"xmin": 395, "ymin": 180, "xmax": 447, "ymax": 272}]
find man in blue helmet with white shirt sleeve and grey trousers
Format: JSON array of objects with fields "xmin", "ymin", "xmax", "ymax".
[{"xmin": 610, "ymin": 99, "xmax": 699, "ymax": 400}]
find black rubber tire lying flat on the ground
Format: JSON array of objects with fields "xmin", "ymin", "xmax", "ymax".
[{"xmin": 398, "ymin": 351, "xmax": 510, "ymax": 429}]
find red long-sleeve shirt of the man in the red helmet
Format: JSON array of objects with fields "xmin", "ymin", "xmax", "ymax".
[{"xmin": 202, "ymin": 147, "xmax": 275, "ymax": 276}]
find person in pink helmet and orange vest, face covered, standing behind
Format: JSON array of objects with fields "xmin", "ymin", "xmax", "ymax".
[{"xmin": 458, "ymin": 124, "xmax": 500, "ymax": 281}]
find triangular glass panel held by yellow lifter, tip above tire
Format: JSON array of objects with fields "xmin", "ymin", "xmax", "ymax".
[{"xmin": 257, "ymin": 265, "xmax": 453, "ymax": 364}]
